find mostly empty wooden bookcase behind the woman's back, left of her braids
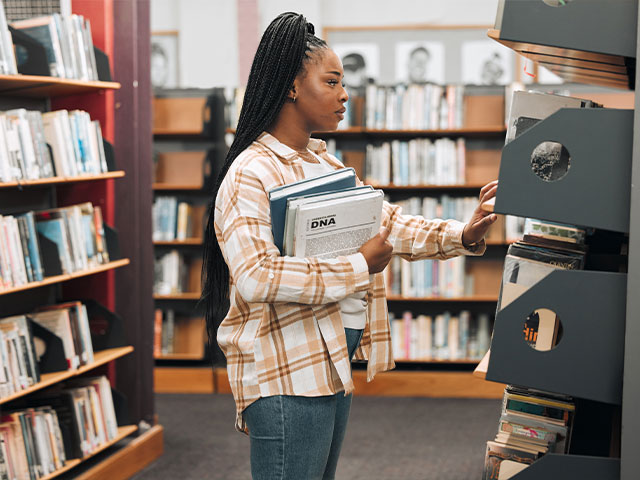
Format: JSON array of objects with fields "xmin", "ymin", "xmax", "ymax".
[{"xmin": 153, "ymin": 89, "xmax": 226, "ymax": 393}]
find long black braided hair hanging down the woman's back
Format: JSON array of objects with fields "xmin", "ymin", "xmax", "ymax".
[{"xmin": 201, "ymin": 12, "xmax": 327, "ymax": 360}]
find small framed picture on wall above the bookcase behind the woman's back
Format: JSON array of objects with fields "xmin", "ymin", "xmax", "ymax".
[{"xmin": 151, "ymin": 30, "xmax": 180, "ymax": 88}]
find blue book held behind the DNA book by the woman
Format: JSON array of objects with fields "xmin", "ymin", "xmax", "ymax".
[{"xmin": 269, "ymin": 168, "xmax": 356, "ymax": 255}]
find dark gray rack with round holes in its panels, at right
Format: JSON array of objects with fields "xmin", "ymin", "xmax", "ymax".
[{"xmin": 487, "ymin": 0, "xmax": 640, "ymax": 480}]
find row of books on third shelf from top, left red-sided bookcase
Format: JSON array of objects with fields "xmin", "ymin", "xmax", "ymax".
[{"xmin": 0, "ymin": 202, "xmax": 109, "ymax": 291}]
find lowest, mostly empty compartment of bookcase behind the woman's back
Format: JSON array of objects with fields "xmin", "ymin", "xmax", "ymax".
[{"xmin": 153, "ymin": 308, "xmax": 205, "ymax": 358}]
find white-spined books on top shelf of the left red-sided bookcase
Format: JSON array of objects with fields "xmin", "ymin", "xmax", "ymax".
[{"xmin": 11, "ymin": 13, "xmax": 98, "ymax": 80}]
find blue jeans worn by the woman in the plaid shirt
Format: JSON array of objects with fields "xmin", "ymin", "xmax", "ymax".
[{"xmin": 244, "ymin": 328, "xmax": 362, "ymax": 480}]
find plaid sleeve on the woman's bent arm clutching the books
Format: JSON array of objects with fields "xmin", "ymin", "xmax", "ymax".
[{"xmin": 216, "ymin": 159, "xmax": 369, "ymax": 304}]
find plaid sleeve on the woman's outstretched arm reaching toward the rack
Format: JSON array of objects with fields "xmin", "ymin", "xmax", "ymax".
[{"xmin": 383, "ymin": 202, "xmax": 486, "ymax": 260}]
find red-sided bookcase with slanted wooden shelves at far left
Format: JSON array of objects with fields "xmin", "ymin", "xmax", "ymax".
[{"xmin": 0, "ymin": 0, "xmax": 163, "ymax": 479}]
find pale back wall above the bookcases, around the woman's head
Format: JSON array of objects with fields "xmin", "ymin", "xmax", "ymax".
[{"xmin": 151, "ymin": 0, "xmax": 498, "ymax": 88}]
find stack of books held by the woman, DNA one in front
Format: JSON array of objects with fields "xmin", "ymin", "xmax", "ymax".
[{"xmin": 269, "ymin": 168, "xmax": 384, "ymax": 258}]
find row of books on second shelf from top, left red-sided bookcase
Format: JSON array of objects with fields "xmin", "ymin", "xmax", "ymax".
[{"xmin": 0, "ymin": 108, "xmax": 108, "ymax": 182}]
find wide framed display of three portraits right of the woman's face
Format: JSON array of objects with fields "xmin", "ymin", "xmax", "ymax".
[{"xmin": 323, "ymin": 25, "xmax": 521, "ymax": 85}]
